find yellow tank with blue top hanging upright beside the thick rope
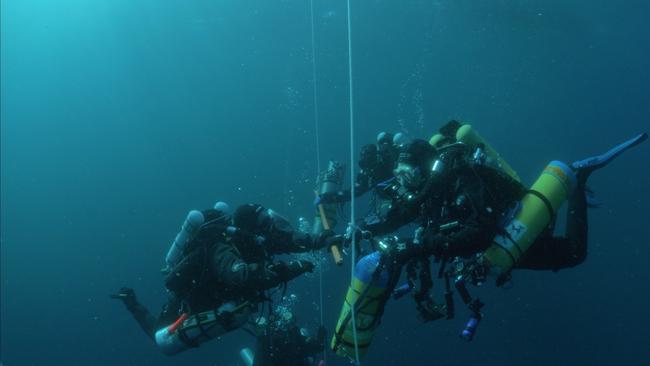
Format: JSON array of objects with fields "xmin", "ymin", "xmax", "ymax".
[{"xmin": 331, "ymin": 252, "xmax": 394, "ymax": 358}]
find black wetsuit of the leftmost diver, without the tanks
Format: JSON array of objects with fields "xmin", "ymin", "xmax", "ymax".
[{"xmin": 125, "ymin": 210, "xmax": 321, "ymax": 339}]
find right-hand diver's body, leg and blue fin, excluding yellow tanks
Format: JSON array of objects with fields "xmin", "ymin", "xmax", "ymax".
[{"xmin": 363, "ymin": 121, "xmax": 647, "ymax": 271}]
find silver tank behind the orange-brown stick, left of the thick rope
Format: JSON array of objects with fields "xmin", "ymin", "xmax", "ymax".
[{"xmin": 312, "ymin": 161, "xmax": 345, "ymax": 235}]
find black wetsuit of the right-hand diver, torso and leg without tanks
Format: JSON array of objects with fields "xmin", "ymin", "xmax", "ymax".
[{"xmin": 364, "ymin": 149, "xmax": 587, "ymax": 270}]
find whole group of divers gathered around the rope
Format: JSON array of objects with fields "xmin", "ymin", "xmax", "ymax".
[{"xmin": 111, "ymin": 121, "xmax": 647, "ymax": 366}]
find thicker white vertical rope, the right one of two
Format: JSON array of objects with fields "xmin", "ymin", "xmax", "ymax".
[{"xmin": 347, "ymin": 0, "xmax": 360, "ymax": 365}]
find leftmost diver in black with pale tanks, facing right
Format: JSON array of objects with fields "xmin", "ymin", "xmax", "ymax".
[{"xmin": 112, "ymin": 203, "xmax": 338, "ymax": 355}]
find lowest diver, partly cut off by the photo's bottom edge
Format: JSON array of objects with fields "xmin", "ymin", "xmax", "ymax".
[{"xmin": 239, "ymin": 294, "xmax": 326, "ymax": 366}]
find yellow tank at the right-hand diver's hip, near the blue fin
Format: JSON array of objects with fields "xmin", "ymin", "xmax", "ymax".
[{"xmin": 484, "ymin": 161, "xmax": 576, "ymax": 273}]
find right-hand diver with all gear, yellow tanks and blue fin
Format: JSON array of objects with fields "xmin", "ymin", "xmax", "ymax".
[{"xmin": 332, "ymin": 122, "xmax": 647, "ymax": 356}]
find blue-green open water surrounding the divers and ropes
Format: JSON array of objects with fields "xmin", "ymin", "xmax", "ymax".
[{"xmin": 0, "ymin": 0, "xmax": 650, "ymax": 366}]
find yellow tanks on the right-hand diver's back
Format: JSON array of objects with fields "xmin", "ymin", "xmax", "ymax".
[{"xmin": 429, "ymin": 124, "xmax": 521, "ymax": 182}]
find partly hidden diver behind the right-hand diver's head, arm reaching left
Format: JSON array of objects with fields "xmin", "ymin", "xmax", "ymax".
[{"xmin": 316, "ymin": 132, "xmax": 406, "ymax": 211}]
